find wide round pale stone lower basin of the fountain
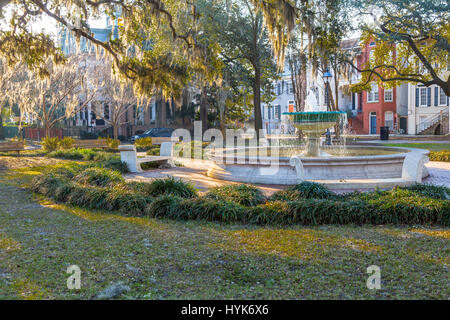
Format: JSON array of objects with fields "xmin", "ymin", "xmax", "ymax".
[{"xmin": 207, "ymin": 146, "xmax": 428, "ymax": 189}]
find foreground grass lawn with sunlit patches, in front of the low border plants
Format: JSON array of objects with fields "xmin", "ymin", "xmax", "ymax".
[{"xmin": 0, "ymin": 156, "xmax": 450, "ymax": 300}]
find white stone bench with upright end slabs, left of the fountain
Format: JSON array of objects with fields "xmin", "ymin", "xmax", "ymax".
[{"xmin": 119, "ymin": 142, "xmax": 173, "ymax": 173}]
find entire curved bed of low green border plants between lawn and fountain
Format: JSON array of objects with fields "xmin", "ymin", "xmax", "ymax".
[{"xmin": 31, "ymin": 165, "xmax": 450, "ymax": 226}]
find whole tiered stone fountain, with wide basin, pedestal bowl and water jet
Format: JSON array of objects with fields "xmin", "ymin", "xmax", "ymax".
[{"xmin": 207, "ymin": 90, "xmax": 428, "ymax": 189}]
